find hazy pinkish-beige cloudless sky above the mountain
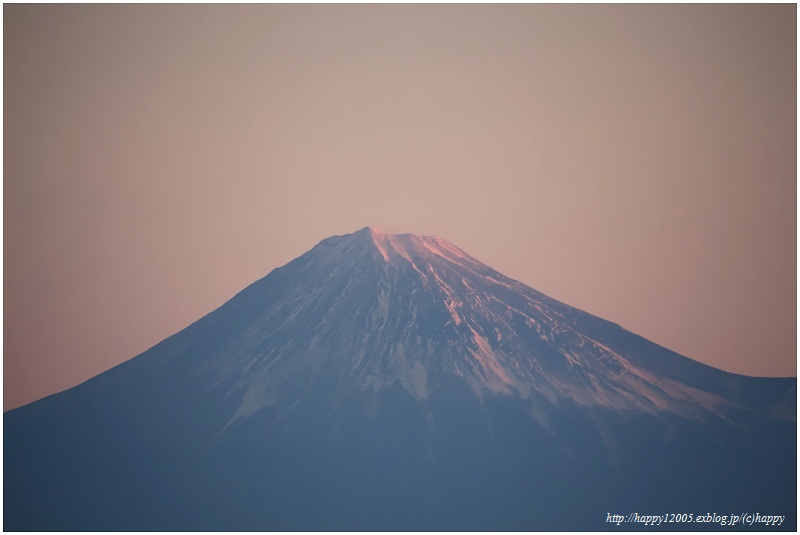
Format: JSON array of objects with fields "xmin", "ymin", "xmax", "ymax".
[{"xmin": 3, "ymin": 4, "xmax": 797, "ymax": 410}]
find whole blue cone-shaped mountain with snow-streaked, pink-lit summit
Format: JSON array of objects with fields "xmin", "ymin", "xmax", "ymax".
[{"xmin": 3, "ymin": 228, "xmax": 797, "ymax": 531}]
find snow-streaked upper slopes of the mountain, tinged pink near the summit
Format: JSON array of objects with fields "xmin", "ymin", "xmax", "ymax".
[{"xmin": 205, "ymin": 228, "xmax": 727, "ymax": 428}]
